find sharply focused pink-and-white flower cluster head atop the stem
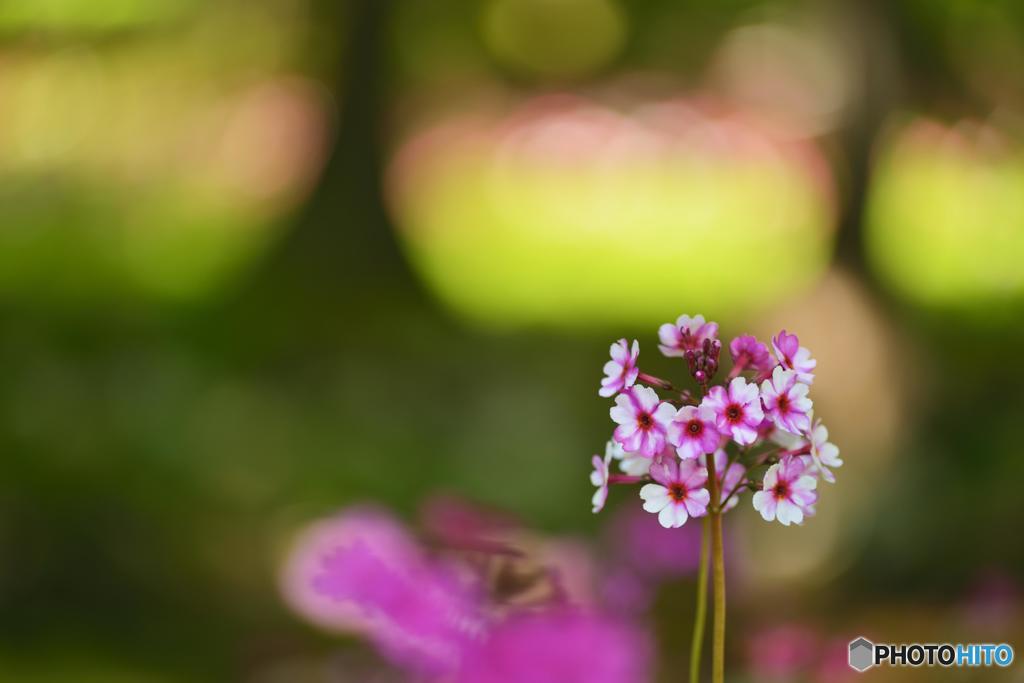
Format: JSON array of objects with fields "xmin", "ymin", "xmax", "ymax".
[{"xmin": 591, "ymin": 315, "xmax": 843, "ymax": 528}]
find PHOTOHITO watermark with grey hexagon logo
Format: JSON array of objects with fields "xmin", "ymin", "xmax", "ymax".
[{"xmin": 849, "ymin": 636, "xmax": 1014, "ymax": 673}]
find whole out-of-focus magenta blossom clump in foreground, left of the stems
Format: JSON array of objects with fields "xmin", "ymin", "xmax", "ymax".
[{"xmin": 283, "ymin": 505, "xmax": 647, "ymax": 683}]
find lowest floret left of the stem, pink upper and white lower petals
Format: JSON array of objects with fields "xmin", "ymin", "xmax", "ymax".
[{"xmin": 640, "ymin": 454, "xmax": 711, "ymax": 528}]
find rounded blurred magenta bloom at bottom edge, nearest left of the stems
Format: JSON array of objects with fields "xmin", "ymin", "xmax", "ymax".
[{"xmin": 456, "ymin": 610, "xmax": 649, "ymax": 683}]
